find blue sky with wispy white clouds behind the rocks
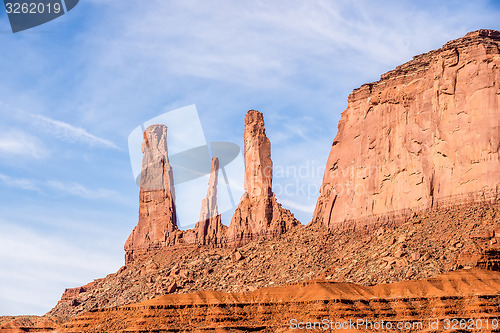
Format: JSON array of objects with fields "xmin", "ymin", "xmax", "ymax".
[{"xmin": 0, "ymin": 0, "xmax": 500, "ymax": 315}]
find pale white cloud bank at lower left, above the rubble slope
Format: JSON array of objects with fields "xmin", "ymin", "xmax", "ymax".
[{"xmin": 0, "ymin": 219, "xmax": 122, "ymax": 315}]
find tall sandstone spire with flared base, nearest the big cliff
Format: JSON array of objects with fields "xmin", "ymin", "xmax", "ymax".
[{"xmin": 227, "ymin": 110, "xmax": 300, "ymax": 246}]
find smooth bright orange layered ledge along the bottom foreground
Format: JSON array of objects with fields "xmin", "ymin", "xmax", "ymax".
[{"xmin": 62, "ymin": 269, "xmax": 500, "ymax": 332}]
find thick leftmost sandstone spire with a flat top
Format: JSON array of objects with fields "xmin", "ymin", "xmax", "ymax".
[{"xmin": 125, "ymin": 125, "xmax": 178, "ymax": 263}]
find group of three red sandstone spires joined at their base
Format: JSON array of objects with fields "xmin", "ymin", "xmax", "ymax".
[{"xmin": 125, "ymin": 110, "xmax": 300, "ymax": 263}]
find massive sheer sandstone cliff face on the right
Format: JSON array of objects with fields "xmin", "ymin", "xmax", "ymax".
[{"xmin": 313, "ymin": 30, "xmax": 500, "ymax": 228}]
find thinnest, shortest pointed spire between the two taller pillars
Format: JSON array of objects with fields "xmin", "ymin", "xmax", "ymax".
[{"xmin": 195, "ymin": 157, "xmax": 227, "ymax": 245}]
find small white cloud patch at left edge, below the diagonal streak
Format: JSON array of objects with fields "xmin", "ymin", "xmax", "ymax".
[{"xmin": 0, "ymin": 130, "xmax": 48, "ymax": 159}]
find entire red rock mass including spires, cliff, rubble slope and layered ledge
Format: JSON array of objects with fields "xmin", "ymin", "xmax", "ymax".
[{"xmin": 9, "ymin": 30, "xmax": 500, "ymax": 332}]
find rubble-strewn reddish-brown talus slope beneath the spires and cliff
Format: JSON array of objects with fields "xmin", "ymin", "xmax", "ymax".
[{"xmin": 49, "ymin": 198, "xmax": 500, "ymax": 317}]
